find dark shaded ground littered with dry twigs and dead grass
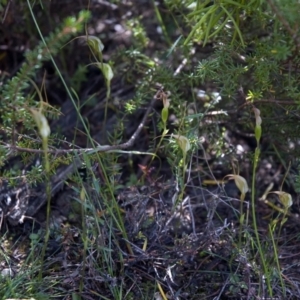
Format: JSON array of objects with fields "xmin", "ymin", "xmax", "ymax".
[{"xmin": 0, "ymin": 1, "xmax": 300, "ymax": 299}]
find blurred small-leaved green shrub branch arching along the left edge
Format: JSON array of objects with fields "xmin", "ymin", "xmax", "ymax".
[{"xmin": 0, "ymin": 11, "xmax": 90, "ymax": 175}]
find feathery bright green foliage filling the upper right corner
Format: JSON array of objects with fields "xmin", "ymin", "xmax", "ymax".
[{"xmin": 159, "ymin": 0, "xmax": 300, "ymax": 159}]
